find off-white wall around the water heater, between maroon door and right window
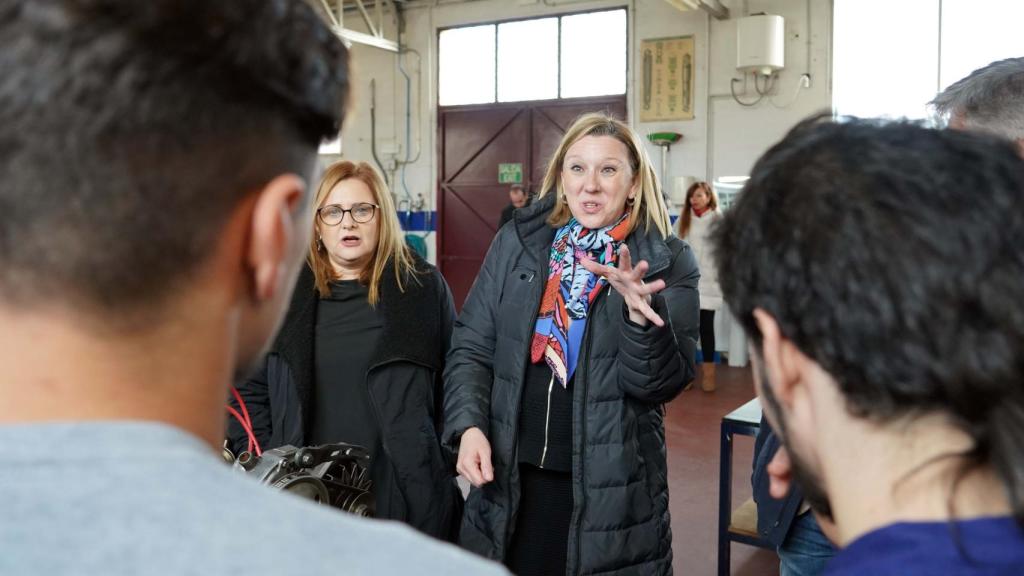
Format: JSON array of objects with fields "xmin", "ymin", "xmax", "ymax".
[{"xmin": 634, "ymin": 0, "xmax": 831, "ymax": 192}]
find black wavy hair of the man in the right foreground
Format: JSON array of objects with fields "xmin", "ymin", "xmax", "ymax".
[{"xmin": 713, "ymin": 118, "xmax": 1024, "ymax": 526}]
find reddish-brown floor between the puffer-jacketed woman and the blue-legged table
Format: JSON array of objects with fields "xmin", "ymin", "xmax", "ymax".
[{"xmin": 665, "ymin": 365, "xmax": 778, "ymax": 576}]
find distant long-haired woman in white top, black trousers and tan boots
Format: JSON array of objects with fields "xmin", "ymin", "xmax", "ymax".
[{"xmin": 679, "ymin": 182, "xmax": 722, "ymax": 392}]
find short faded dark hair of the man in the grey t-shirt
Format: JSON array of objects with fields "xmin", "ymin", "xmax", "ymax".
[{"xmin": 0, "ymin": 0, "xmax": 348, "ymax": 313}]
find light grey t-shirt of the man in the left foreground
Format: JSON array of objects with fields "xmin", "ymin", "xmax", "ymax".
[{"xmin": 0, "ymin": 421, "xmax": 503, "ymax": 576}]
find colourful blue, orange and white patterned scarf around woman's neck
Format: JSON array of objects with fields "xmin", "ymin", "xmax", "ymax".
[{"xmin": 529, "ymin": 212, "xmax": 630, "ymax": 387}]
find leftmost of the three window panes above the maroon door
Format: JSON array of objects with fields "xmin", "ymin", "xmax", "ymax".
[{"xmin": 437, "ymin": 24, "xmax": 495, "ymax": 106}]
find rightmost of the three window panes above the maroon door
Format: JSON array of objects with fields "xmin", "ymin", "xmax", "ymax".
[{"xmin": 561, "ymin": 10, "xmax": 626, "ymax": 98}]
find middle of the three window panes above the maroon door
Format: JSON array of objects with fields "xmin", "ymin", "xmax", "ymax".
[{"xmin": 498, "ymin": 18, "xmax": 558, "ymax": 102}]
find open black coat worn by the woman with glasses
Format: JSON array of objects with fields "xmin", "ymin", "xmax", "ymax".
[{"xmin": 228, "ymin": 255, "xmax": 462, "ymax": 540}]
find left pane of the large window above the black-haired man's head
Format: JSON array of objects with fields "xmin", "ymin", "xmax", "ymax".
[{"xmin": 834, "ymin": 0, "xmax": 939, "ymax": 118}]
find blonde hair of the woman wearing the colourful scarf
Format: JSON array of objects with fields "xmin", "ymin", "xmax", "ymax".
[{"xmin": 539, "ymin": 113, "xmax": 672, "ymax": 238}]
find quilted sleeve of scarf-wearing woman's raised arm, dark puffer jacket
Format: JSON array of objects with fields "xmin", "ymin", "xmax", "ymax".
[{"xmin": 618, "ymin": 237, "xmax": 700, "ymax": 404}]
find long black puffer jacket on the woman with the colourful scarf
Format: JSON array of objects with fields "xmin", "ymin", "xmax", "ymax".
[{"xmin": 442, "ymin": 195, "xmax": 699, "ymax": 576}]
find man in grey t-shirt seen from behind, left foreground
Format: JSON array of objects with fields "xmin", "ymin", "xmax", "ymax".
[{"xmin": 0, "ymin": 0, "xmax": 506, "ymax": 576}]
